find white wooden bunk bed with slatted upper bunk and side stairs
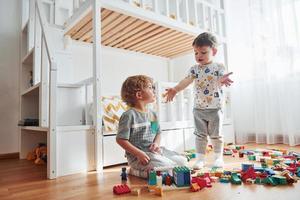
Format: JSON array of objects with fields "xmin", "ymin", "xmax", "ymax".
[{"xmin": 21, "ymin": 0, "xmax": 227, "ymax": 178}]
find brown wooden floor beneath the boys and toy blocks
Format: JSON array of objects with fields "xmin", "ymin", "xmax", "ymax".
[{"xmin": 0, "ymin": 145, "xmax": 300, "ymax": 200}]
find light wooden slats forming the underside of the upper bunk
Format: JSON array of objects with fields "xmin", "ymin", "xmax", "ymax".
[{"xmin": 66, "ymin": 8, "xmax": 195, "ymax": 57}]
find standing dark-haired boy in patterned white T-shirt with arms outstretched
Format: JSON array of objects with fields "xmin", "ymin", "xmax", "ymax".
[{"xmin": 166, "ymin": 32, "xmax": 232, "ymax": 169}]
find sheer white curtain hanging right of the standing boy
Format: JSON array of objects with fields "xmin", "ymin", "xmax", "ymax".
[{"xmin": 228, "ymin": 0, "xmax": 300, "ymax": 146}]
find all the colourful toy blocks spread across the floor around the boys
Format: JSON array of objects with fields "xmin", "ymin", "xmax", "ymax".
[{"xmin": 113, "ymin": 145, "xmax": 300, "ymax": 196}]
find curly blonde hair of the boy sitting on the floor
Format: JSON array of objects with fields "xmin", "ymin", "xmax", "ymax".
[{"xmin": 121, "ymin": 75, "xmax": 153, "ymax": 107}]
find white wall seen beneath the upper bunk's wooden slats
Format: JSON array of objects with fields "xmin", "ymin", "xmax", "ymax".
[{"xmin": 70, "ymin": 42, "xmax": 168, "ymax": 95}]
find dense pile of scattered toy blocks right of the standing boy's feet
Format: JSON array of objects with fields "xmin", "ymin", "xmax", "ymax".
[{"xmin": 206, "ymin": 145, "xmax": 300, "ymax": 186}]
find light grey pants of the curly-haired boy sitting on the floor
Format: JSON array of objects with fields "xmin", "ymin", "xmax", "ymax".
[{"xmin": 128, "ymin": 147, "xmax": 187, "ymax": 171}]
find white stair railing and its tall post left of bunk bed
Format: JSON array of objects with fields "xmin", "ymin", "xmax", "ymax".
[{"xmin": 35, "ymin": 0, "xmax": 57, "ymax": 179}]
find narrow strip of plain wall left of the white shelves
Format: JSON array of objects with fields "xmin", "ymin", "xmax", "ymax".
[{"xmin": 0, "ymin": 0, "xmax": 21, "ymax": 154}]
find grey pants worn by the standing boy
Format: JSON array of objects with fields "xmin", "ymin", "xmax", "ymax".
[{"xmin": 193, "ymin": 108, "xmax": 223, "ymax": 154}]
